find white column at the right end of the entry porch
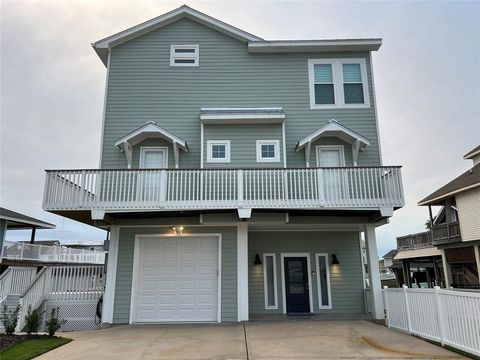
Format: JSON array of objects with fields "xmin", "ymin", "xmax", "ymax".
[{"xmin": 365, "ymin": 225, "xmax": 385, "ymax": 320}]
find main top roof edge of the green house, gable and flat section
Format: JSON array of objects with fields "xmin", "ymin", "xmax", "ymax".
[{"xmin": 92, "ymin": 5, "xmax": 382, "ymax": 65}]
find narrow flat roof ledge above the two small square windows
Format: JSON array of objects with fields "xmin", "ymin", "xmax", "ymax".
[{"xmin": 200, "ymin": 107, "xmax": 285, "ymax": 124}]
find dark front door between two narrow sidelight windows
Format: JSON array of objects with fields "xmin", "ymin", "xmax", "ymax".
[{"xmin": 284, "ymin": 257, "xmax": 310, "ymax": 313}]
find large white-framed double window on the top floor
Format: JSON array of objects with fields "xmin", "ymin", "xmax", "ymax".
[{"xmin": 308, "ymin": 59, "xmax": 370, "ymax": 109}]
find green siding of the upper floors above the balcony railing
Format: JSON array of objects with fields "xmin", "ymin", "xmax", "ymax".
[{"xmin": 102, "ymin": 19, "xmax": 380, "ymax": 168}]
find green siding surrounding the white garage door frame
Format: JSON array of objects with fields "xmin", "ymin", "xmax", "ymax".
[{"xmin": 113, "ymin": 226, "xmax": 237, "ymax": 324}]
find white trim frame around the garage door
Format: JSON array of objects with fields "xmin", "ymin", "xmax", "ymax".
[{"xmin": 128, "ymin": 233, "xmax": 222, "ymax": 324}]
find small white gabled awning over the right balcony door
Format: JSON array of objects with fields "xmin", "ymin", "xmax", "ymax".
[{"xmin": 295, "ymin": 119, "xmax": 370, "ymax": 167}]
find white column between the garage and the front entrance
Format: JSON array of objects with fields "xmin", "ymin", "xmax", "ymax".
[{"xmin": 237, "ymin": 222, "xmax": 248, "ymax": 321}]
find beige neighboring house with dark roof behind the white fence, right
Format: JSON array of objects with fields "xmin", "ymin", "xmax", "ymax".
[{"xmin": 394, "ymin": 146, "xmax": 480, "ymax": 288}]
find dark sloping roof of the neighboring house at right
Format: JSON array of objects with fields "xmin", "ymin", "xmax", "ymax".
[{"xmin": 418, "ymin": 164, "xmax": 480, "ymax": 205}]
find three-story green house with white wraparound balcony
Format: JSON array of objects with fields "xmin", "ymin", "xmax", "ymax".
[{"xmin": 43, "ymin": 6, "xmax": 404, "ymax": 324}]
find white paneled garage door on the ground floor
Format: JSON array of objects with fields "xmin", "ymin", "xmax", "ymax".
[{"xmin": 133, "ymin": 237, "xmax": 218, "ymax": 323}]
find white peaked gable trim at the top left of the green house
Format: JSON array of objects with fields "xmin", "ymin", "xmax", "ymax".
[{"xmin": 92, "ymin": 5, "xmax": 262, "ymax": 49}]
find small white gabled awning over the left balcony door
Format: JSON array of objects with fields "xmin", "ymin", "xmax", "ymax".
[{"xmin": 115, "ymin": 121, "xmax": 188, "ymax": 169}]
